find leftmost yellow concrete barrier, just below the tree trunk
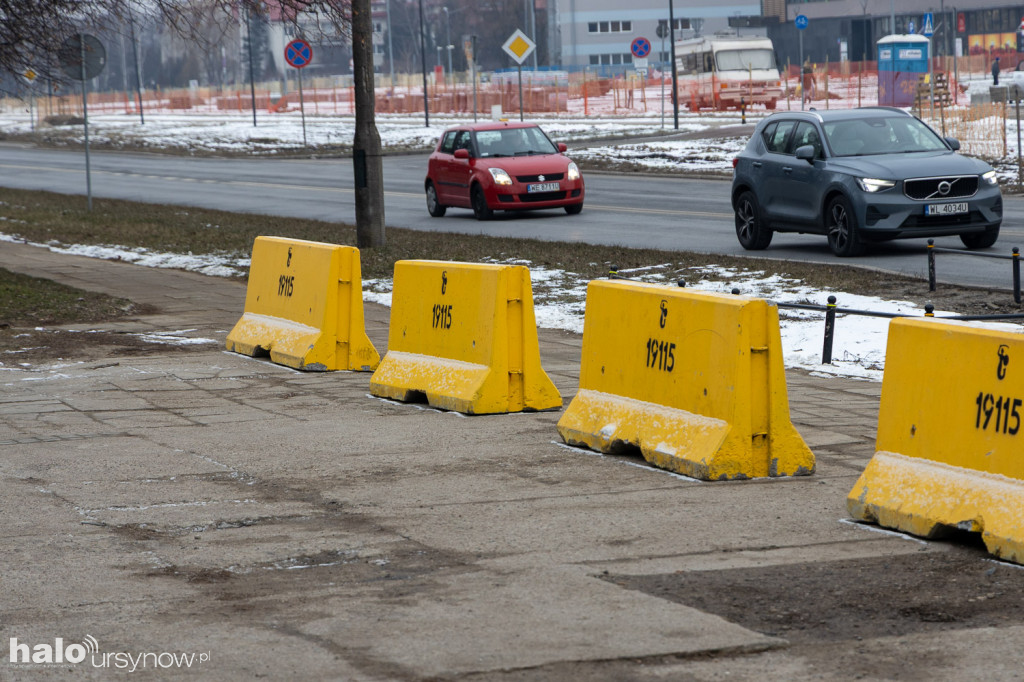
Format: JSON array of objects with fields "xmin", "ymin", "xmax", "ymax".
[{"xmin": 226, "ymin": 237, "xmax": 380, "ymax": 372}]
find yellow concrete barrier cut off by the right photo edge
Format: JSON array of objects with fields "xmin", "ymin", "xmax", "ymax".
[{"xmin": 847, "ymin": 319, "xmax": 1024, "ymax": 563}]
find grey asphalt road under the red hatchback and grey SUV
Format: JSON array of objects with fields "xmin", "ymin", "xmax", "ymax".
[{"xmin": 0, "ymin": 144, "xmax": 1024, "ymax": 289}]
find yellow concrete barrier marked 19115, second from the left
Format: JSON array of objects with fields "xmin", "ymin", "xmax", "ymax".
[{"xmin": 370, "ymin": 260, "xmax": 562, "ymax": 415}]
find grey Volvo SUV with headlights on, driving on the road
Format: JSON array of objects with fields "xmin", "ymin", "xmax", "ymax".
[{"xmin": 732, "ymin": 106, "xmax": 1002, "ymax": 256}]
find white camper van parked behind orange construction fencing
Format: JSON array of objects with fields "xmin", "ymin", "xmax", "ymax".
[{"xmin": 676, "ymin": 36, "xmax": 782, "ymax": 112}]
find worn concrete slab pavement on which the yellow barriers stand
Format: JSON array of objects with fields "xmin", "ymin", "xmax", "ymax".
[{"xmin": 0, "ymin": 243, "xmax": 1024, "ymax": 680}]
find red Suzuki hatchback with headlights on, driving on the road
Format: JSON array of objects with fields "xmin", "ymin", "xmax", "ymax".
[{"xmin": 424, "ymin": 121, "xmax": 584, "ymax": 220}]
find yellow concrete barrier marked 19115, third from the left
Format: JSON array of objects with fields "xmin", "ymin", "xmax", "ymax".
[{"xmin": 558, "ymin": 281, "xmax": 814, "ymax": 480}]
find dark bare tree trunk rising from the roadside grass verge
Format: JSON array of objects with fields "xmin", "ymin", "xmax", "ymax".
[{"xmin": 352, "ymin": 0, "xmax": 384, "ymax": 249}]
